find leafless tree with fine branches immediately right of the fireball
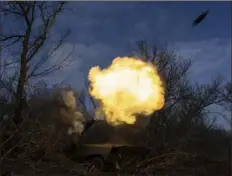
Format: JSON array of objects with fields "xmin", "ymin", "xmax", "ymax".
[{"xmin": 135, "ymin": 41, "xmax": 222, "ymax": 150}]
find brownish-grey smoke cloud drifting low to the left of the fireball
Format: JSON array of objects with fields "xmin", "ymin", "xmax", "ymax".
[{"xmin": 28, "ymin": 88, "xmax": 85, "ymax": 135}]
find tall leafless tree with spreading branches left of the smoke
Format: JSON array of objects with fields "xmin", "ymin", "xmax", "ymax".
[{"xmin": 0, "ymin": 1, "xmax": 68, "ymax": 125}]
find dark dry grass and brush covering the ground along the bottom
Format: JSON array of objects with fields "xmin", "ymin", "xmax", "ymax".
[{"xmin": 0, "ymin": 108, "xmax": 229, "ymax": 176}]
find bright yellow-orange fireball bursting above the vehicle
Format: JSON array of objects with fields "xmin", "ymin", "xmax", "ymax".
[{"xmin": 88, "ymin": 57, "xmax": 164, "ymax": 125}]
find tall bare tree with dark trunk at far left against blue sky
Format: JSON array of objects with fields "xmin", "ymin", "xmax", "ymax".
[{"xmin": 0, "ymin": 1, "xmax": 69, "ymax": 123}]
